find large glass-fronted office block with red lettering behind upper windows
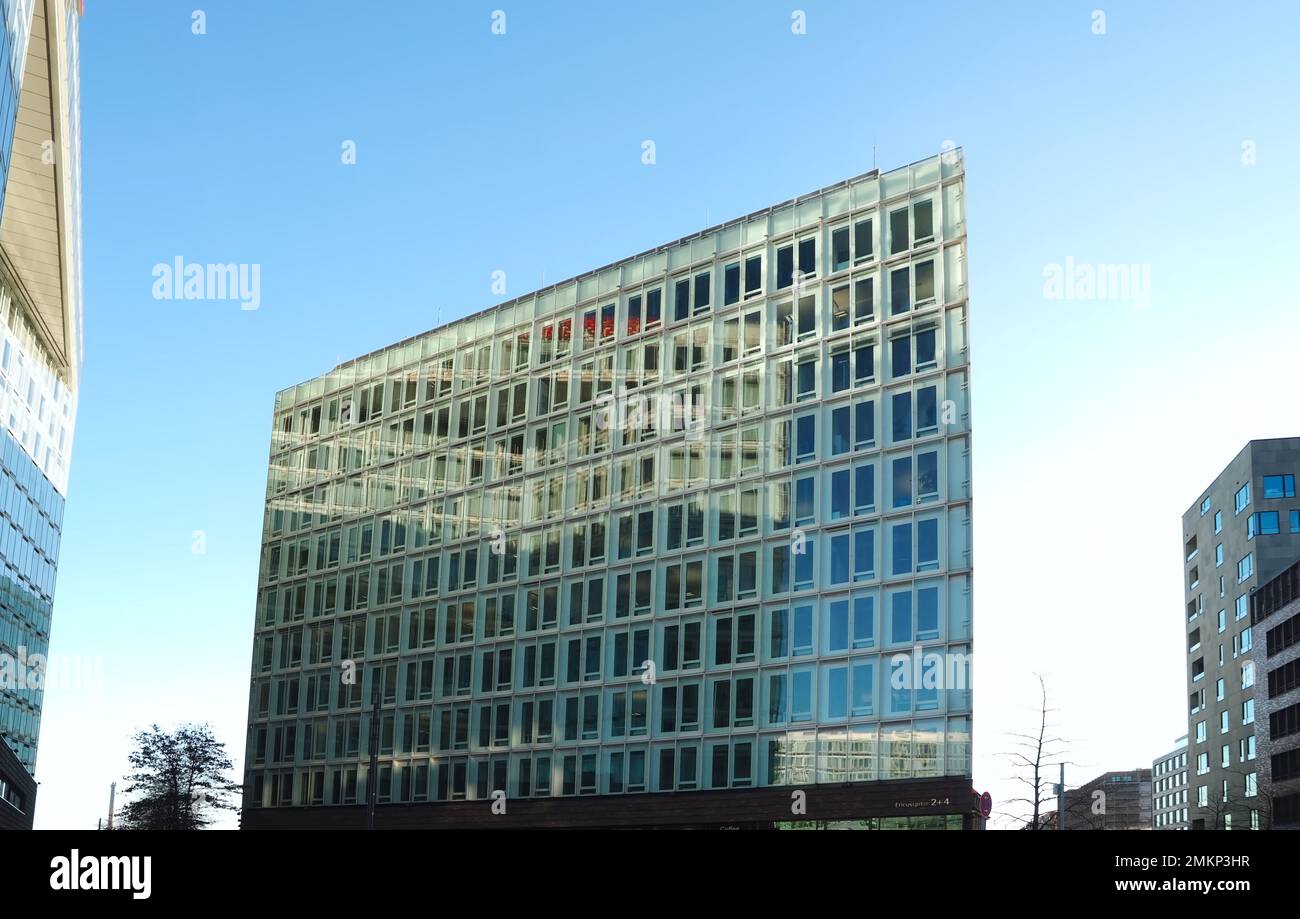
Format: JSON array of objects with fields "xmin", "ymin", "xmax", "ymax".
[{"xmin": 243, "ymin": 151, "xmax": 974, "ymax": 828}]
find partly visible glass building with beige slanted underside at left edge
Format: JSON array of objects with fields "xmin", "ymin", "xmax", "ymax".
[{"xmin": 0, "ymin": 0, "xmax": 82, "ymax": 825}]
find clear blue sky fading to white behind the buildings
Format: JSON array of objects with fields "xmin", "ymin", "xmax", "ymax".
[{"xmin": 36, "ymin": 0, "xmax": 1300, "ymax": 827}]
